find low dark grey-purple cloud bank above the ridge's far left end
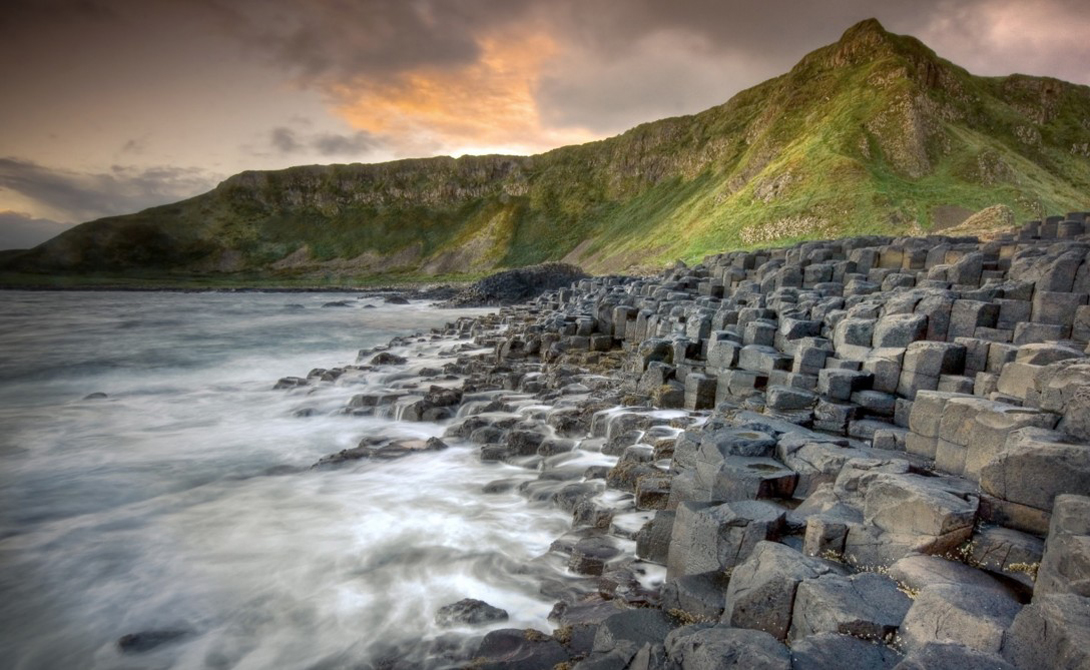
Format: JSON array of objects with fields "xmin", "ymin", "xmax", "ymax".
[{"xmin": 0, "ymin": 157, "xmax": 221, "ymax": 222}]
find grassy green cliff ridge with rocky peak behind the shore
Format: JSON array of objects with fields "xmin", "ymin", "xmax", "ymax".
[{"xmin": 7, "ymin": 20, "xmax": 1090, "ymax": 275}]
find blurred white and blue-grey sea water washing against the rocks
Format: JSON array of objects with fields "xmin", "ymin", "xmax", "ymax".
[{"xmin": 0, "ymin": 292, "xmax": 569, "ymax": 669}]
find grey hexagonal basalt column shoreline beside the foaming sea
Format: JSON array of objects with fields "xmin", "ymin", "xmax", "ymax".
[{"xmin": 277, "ymin": 212, "xmax": 1090, "ymax": 670}]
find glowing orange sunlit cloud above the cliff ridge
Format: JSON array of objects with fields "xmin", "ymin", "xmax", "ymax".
[{"xmin": 334, "ymin": 30, "xmax": 598, "ymax": 155}]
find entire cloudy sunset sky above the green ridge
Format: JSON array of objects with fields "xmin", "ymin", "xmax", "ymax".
[{"xmin": 0, "ymin": 0, "xmax": 1090, "ymax": 249}]
